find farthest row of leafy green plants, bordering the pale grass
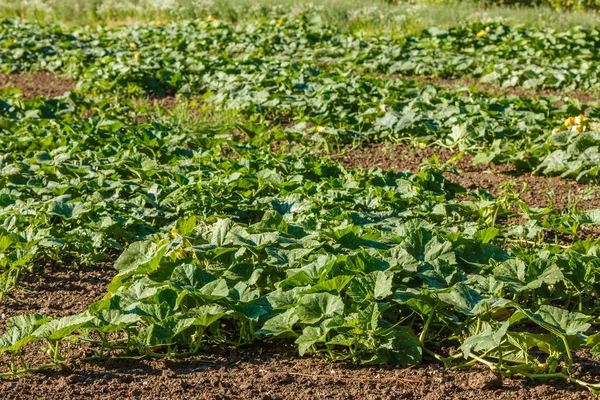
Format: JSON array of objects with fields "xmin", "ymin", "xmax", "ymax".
[{"xmin": 0, "ymin": 16, "xmax": 600, "ymax": 92}]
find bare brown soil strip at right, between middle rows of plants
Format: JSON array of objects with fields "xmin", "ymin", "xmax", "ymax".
[{"xmin": 334, "ymin": 144, "xmax": 600, "ymax": 209}]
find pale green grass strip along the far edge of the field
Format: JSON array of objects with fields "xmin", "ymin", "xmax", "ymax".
[{"xmin": 0, "ymin": 0, "xmax": 598, "ymax": 35}]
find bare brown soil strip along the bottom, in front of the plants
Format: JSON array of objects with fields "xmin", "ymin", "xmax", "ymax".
[{"xmin": 0, "ymin": 346, "xmax": 594, "ymax": 400}]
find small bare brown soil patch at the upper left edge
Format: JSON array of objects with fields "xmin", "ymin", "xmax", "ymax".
[{"xmin": 0, "ymin": 72, "xmax": 77, "ymax": 99}]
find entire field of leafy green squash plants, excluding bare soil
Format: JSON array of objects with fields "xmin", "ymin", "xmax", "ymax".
[{"xmin": 0, "ymin": 14, "xmax": 600, "ymax": 393}]
